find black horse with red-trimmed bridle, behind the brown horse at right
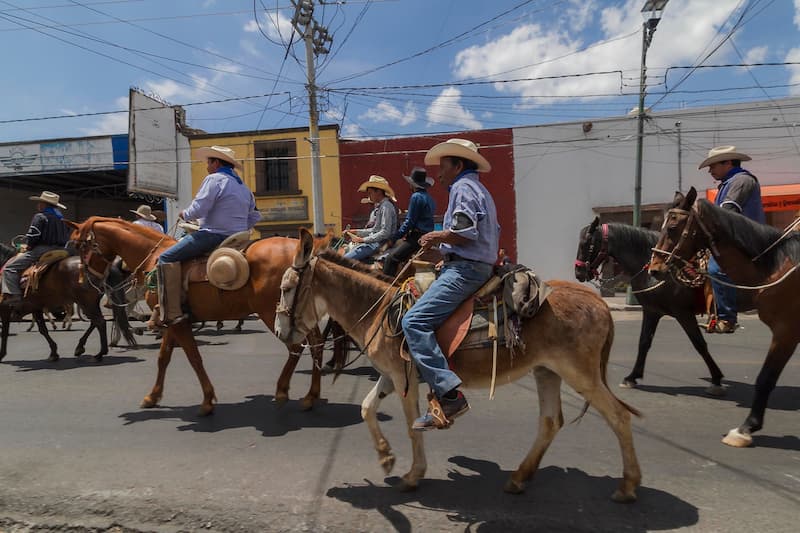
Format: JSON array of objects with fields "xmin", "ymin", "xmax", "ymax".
[{"xmin": 575, "ymin": 218, "xmax": 725, "ymax": 396}]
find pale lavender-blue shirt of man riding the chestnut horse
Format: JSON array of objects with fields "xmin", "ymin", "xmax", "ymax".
[{"xmin": 183, "ymin": 168, "xmax": 261, "ymax": 236}]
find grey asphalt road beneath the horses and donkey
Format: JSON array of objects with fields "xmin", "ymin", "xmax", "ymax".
[{"xmin": 0, "ymin": 312, "xmax": 800, "ymax": 532}]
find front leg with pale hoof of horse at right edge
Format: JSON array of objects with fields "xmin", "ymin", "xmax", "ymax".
[{"xmin": 722, "ymin": 332, "xmax": 797, "ymax": 448}]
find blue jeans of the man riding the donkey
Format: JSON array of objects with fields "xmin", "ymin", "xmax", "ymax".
[{"xmin": 403, "ymin": 261, "xmax": 493, "ymax": 398}]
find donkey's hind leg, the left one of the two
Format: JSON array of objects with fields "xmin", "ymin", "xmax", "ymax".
[{"xmin": 503, "ymin": 366, "xmax": 564, "ymax": 494}]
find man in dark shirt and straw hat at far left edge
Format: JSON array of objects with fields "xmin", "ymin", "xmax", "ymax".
[{"xmin": 0, "ymin": 191, "xmax": 70, "ymax": 304}]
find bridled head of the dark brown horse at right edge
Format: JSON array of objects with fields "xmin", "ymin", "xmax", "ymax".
[{"xmin": 649, "ymin": 187, "xmax": 708, "ymax": 279}]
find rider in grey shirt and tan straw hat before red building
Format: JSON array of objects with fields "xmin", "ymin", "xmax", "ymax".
[{"xmin": 345, "ymin": 176, "xmax": 397, "ymax": 261}]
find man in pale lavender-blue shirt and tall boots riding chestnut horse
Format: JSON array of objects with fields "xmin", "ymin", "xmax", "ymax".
[{"xmin": 150, "ymin": 146, "xmax": 261, "ymax": 326}]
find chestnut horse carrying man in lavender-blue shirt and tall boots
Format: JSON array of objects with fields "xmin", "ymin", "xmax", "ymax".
[{"xmin": 72, "ymin": 217, "xmax": 322, "ymax": 415}]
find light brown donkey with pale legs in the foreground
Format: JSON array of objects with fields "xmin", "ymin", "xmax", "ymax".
[{"xmin": 275, "ymin": 231, "xmax": 641, "ymax": 502}]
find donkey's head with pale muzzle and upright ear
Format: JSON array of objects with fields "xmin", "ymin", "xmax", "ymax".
[{"xmin": 275, "ymin": 229, "xmax": 319, "ymax": 344}]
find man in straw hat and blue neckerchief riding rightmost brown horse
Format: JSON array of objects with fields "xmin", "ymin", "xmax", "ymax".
[{"xmin": 697, "ymin": 146, "xmax": 766, "ymax": 333}]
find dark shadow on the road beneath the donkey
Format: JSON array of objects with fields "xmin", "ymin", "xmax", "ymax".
[{"xmin": 326, "ymin": 456, "xmax": 699, "ymax": 533}]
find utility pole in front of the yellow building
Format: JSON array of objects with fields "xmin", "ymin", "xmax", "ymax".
[{"xmin": 292, "ymin": 0, "xmax": 333, "ymax": 235}]
